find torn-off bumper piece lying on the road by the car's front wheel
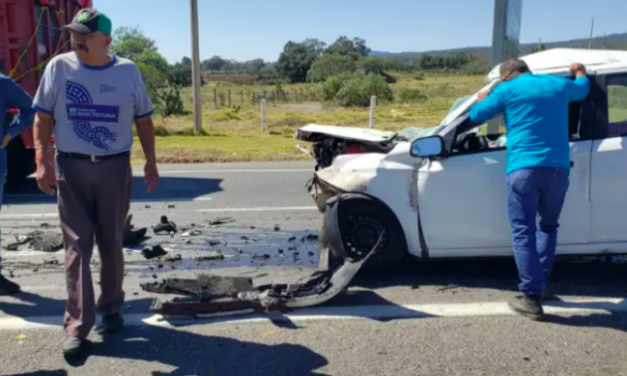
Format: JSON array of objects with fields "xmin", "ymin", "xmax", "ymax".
[{"xmin": 141, "ymin": 196, "xmax": 384, "ymax": 318}]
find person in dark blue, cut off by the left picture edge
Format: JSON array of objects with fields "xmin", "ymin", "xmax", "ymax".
[{"xmin": 0, "ymin": 74, "xmax": 35, "ymax": 295}]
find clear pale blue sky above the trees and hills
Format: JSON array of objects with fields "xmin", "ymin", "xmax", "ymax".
[{"xmin": 94, "ymin": 0, "xmax": 627, "ymax": 62}]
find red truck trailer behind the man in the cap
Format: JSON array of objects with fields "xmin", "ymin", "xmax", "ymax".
[{"xmin": 0, "ymin": 0, "xmax": 92, "ymax": 180}]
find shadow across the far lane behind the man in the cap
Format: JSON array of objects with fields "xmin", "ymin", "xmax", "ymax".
[{"xmin": 4, "ymin": 176, "xmax": 223, "ymax": 205}]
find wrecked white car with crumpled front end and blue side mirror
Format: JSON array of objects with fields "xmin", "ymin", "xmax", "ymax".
[{"xmin": 296, "ymin": 49, "xmax": 627, "ymax": 268}]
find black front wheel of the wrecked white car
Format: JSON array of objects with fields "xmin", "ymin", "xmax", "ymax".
[{"xmin": 324, "ymin": 194, "xmax": 407, "ymax": 270}]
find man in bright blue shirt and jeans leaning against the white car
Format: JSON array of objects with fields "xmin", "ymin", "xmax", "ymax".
[{"xmin": 470, "ymin": 59, "xmax": 590, "ymax": 320}]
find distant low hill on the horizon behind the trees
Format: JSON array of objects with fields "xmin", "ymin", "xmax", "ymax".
[{"xmin": 370, "ymin": 33, "xmax": 627, "ymax": 59}]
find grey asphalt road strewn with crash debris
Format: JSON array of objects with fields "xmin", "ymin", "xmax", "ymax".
[{"xmin": 0, "ymin": 163, "xmax": 627, "ymax": 376}]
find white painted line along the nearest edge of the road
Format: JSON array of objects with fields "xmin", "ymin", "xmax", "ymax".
[{"xmin": 0, "ymin": 298, "xmax": 627, "ymax": 331}]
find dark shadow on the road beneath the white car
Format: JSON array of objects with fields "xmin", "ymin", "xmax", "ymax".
[{"xmin": 352, "ymin": 257, "xmax": 627, "ymax": 297}]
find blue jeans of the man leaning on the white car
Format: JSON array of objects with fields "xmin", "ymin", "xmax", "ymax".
[{"xmin": 507, "ymin": 167, "xmax": 569, "ymax": 295}]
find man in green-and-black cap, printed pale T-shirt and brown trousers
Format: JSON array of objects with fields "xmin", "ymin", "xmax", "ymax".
[{"xmin": 33, "ymin": 9, "xmax": 158, "ymax": 355}]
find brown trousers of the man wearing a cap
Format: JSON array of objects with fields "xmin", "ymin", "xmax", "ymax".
[{"xmin": 55, "ymin": 154, "xmax": 132, "ymax": 338}]
